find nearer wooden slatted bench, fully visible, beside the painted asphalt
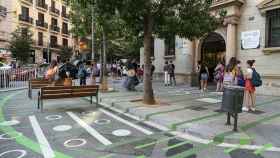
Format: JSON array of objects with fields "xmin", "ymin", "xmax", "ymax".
[{"xmin": 38, "ymin": 85, "xmax": 99, "ymax": 111}]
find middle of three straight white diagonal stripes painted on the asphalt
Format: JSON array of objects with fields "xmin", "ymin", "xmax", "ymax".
[{"xmin": 67, "ymin": 112, "xmax": 112, "ymax": 146}]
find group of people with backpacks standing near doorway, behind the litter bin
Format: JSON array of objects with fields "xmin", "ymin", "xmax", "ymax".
[{"xmin": 197, "ymin": 57, "xmax": 262, "ymax": 111}]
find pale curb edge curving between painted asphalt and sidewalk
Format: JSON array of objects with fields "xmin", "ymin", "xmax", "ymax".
[{"xmin": 92, "ymin": 98, "xmax": 280, "ymax": 152}]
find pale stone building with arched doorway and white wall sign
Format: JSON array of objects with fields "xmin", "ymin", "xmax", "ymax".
[{"xmin": 140, "ymin": 0, "xmax": 280, "ymax": 96}]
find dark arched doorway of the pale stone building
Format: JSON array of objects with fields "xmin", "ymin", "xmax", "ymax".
[{"xmin": 201, "ymin": 32, "xmax": 226, "ymax": 81}]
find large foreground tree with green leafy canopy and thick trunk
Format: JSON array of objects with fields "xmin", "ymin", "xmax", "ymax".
[{"xmin": 70, "ymin": 0, "xmax": 221, "ymax": 104}]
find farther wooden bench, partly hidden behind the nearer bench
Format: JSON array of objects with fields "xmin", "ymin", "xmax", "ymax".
[{"xmin": 28, "ymin": 79, "xmax": 51, "ymax": 99}]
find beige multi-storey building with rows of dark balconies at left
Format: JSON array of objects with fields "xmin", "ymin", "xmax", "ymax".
[{"xmin": 0, "ymin": 0, "xmax": 74, "ymax": 63}]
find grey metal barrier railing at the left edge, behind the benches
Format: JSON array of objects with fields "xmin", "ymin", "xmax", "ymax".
[{"xmin": 0, "ymin": 68, "xmax": 39, "ymax": 89}]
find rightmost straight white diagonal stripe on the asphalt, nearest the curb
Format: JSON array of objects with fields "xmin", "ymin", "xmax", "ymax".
[{"xmin": 100, "ymin": 109, "xmax": 153, "ymax": 135}]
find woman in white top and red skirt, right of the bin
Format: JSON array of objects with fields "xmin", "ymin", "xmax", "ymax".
[{"xmin": 242, "ymin": 60, "xmax": 256, "ymax": 111}]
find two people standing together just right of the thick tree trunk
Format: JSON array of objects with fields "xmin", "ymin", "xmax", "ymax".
[{"xmin": 163, "ymin": 61, "xmax": 176, "ymax": 86}]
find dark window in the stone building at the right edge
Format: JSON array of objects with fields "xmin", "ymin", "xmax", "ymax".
[{"xmin": 266, "ymin": 9, "xmax": 280, "ymax": 47}]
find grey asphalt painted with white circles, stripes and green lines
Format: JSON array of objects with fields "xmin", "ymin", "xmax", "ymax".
[{"xmin": 0, "ymin": 87, "xmax": 280, "ymax": 158}]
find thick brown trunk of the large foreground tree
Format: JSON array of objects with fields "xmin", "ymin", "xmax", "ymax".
[{"xmin": 143, "ymin": 13, "xmax": 155, "ymax": 105}]
